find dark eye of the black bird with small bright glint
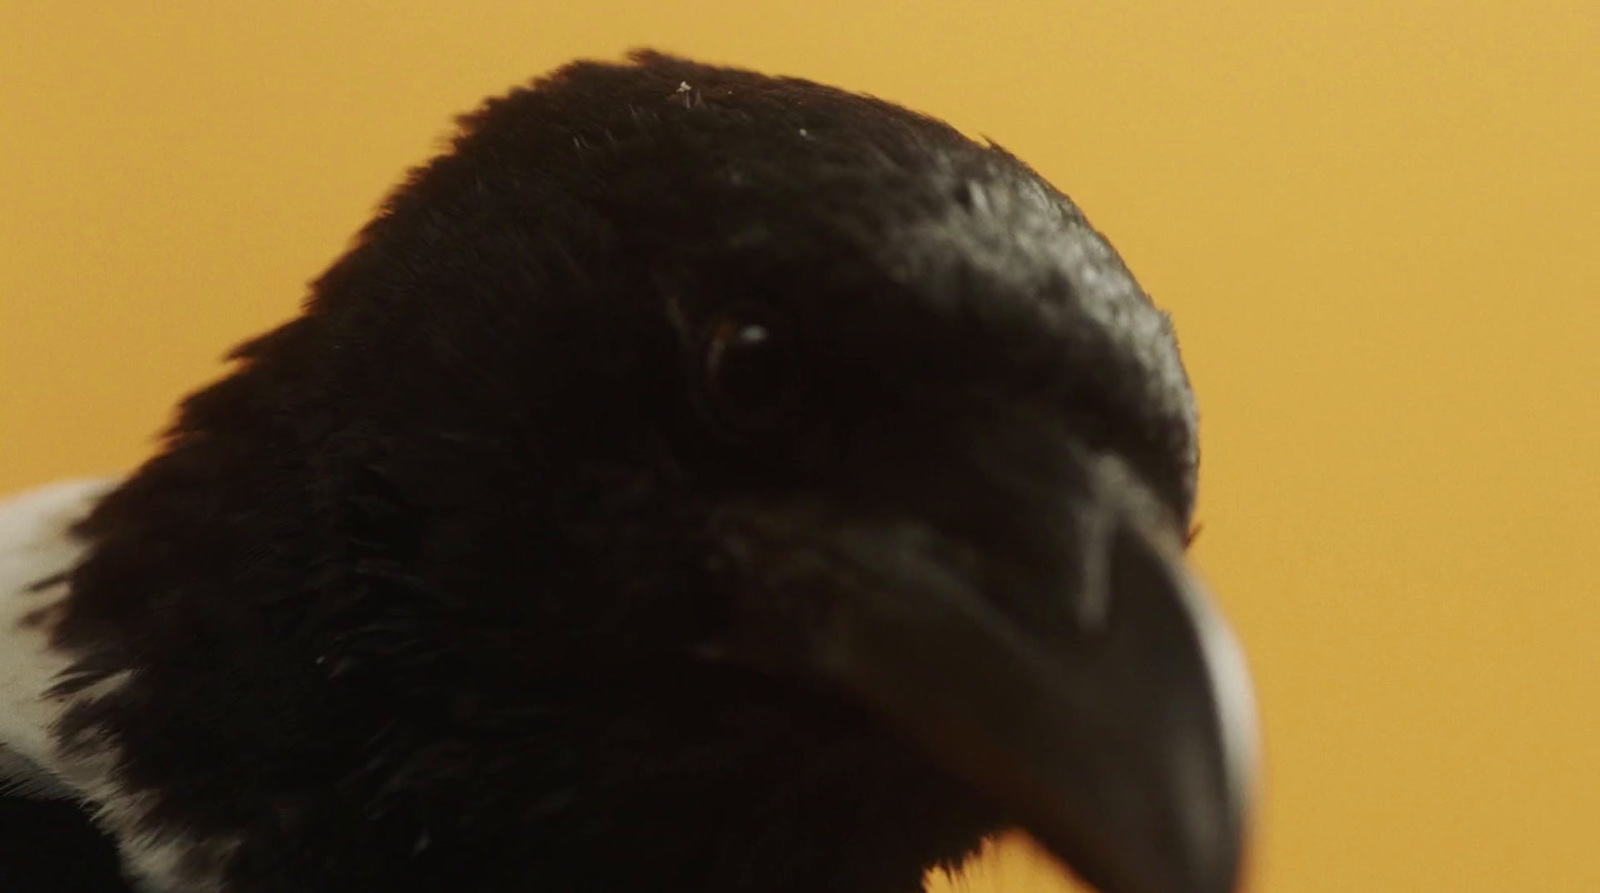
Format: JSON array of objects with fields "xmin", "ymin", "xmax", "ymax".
[{"xmin": 704, "ymin": 312, "xmax": 794, "ymax": 430}]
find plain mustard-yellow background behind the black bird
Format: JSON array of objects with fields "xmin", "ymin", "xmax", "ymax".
[{"xmin": 0, "ymin": 0, "xmax": 1600, "ymax": 893}]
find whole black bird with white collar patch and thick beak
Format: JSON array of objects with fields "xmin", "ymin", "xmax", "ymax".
[{"xmin": 0, "ymin": 51, "xmax": 1256, "ymax": 893}]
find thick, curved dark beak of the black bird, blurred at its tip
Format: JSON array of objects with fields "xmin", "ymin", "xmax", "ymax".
[{"xmin": 728, "ymin": 451, "xmax": 1256, "ymax": 893}]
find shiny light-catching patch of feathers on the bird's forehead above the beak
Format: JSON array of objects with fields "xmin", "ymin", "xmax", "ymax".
[{"xmin": 878, "ymin": 171, "xmax": 1198, "ymax": 490}]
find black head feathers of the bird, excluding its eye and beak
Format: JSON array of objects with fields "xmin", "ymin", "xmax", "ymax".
[{"xmin": 0, "ymin": 54, "xmax": 1248, "ymax": 893}]
